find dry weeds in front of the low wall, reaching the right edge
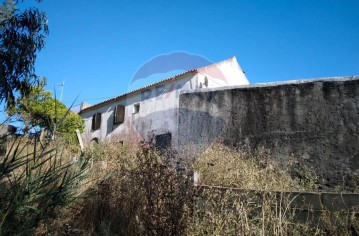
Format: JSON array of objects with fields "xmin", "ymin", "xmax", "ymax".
[{"xmin": 187, "ymin": 188, "xmax": 359, "ymax": 236}]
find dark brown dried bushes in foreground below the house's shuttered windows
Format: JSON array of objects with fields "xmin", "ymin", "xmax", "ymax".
[{"xmin": 64, "ymin": 144, "xmax": 193, "ymax": 235}]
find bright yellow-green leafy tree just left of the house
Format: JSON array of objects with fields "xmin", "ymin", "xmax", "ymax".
[{"xmin": 8, "ymin": 78, "xmax": 84, "ymax": 142}]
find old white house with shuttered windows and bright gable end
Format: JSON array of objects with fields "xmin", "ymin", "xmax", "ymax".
[{"xmin": 79, "ymin": 57, "xmax": 249, "ymax": 147}]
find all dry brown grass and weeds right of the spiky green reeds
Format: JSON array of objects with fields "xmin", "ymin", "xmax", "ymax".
[{"xmin": 33, "ymin": 143, "xmax": 359, "ymax": 235}]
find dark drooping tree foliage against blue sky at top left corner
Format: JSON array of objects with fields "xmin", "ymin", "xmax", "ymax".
[{"xmin": 0, "ymin": 0, "xmax": 48, "ymax": 105}]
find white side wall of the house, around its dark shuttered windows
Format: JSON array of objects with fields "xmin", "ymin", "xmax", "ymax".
[{"xmin": 80, "ymin": 74, "xmax": 195, "ymax": 146}]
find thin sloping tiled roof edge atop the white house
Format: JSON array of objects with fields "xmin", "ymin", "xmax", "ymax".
[{"xmin": 79, "ymin": 69, "xmax": 197, "ymax": 113}]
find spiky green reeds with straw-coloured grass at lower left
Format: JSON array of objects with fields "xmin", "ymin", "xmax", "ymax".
[{"xmin": 0, "ymin": 134, "xmax": 89, "ymax": 235}]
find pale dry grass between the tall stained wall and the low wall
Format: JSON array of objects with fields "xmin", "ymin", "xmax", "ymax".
[{"xmin": 194, "ymin": 144, "xmax": 316, "ymax": 191}]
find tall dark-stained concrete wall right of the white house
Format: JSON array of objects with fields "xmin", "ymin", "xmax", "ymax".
[{"xmin": 179, "ymin": 77, "xmax": 359, "ymax": 189}]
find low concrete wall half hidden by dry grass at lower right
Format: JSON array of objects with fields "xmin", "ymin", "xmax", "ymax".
[{"xmin": 196, "ymin": 185, "xmax": 359, "ymax": 225}]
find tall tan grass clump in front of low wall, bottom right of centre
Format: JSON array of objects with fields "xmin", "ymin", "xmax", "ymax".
[{"xmin": 188, "ymin": 188, "xmax": 303, "ymax": 235}]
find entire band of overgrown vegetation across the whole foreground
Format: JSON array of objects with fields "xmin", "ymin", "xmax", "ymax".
[{"xmin": 0, "ymin": 134, "xmax": 359, "ymax": 235}]
